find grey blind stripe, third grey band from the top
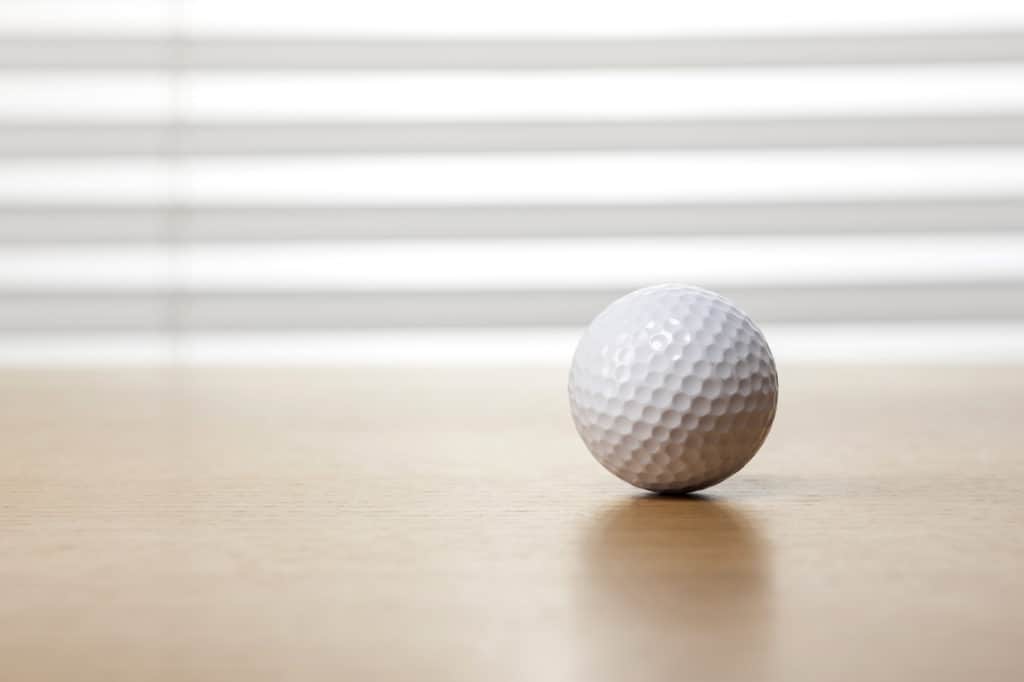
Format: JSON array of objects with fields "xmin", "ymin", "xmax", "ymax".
[{"xmin": 0, "ymin": 193, "xmax": 1024, "ymax": 245}]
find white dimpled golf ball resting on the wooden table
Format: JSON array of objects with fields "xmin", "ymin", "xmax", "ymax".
[{"xmin": 569, "ymin": 285, "xmax": 778, "ymax": 493}]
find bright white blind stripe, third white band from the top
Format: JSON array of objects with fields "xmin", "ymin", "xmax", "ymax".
[{"xmin": 6, "ymin": 153, "xmax": 1024, "ymax": 206}]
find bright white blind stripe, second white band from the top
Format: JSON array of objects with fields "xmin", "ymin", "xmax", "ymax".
[{"xmin": 8, "ymin": 65, "xmax": 1024, "ymax": 120}]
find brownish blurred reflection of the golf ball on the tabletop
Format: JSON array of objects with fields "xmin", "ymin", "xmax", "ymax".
[{"xmin": 578, "ymin": 495, "xmax": 772, "ymax": 680}]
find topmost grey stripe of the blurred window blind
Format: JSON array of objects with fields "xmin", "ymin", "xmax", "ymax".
[{"xmin": 6, "ymin": 30, "xmax": 1024, "ymax": 71}]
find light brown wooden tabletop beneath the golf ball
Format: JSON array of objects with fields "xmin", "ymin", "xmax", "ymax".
[{"xmin": 0, "ymin": 368, "xmax": 1024, "ymax": 682}]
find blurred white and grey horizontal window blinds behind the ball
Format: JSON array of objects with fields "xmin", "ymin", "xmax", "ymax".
[{"xmin": 0, "ymin": 0, "xmax": 1024, "ymax": 365}]
